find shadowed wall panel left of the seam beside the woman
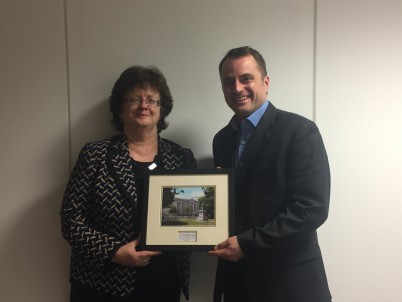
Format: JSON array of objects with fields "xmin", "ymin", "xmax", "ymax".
[{"xmin": 0, "ymin": 0, "xmax": 69, "ymax": 302}]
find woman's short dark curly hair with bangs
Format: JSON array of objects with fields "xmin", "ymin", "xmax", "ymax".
[{"xmin": 109, "ymin": 65, "xmax": 173, "ymax": 133}]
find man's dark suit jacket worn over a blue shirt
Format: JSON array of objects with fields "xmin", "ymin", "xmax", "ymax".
[{"xmin": 213, "ymin": 103, "xmax": 331, "ymax": 302}]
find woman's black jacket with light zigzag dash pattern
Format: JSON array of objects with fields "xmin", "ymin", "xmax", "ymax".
[{"xmin": 61, "ymin": 135, "xmax": 196, "ymax": 300}]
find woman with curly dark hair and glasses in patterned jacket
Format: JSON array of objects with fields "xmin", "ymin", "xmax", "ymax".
[{"xmin": 61, "ymin": 66, "xmax": 196, "ymax": 302}]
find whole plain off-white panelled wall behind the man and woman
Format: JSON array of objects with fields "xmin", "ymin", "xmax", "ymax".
[{"xmin": 0, "ymin": 0, "xmax": 402, "ymax": 302}]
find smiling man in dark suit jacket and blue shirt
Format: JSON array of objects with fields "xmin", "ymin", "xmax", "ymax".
[{"xmin": 209, "ymin": 47, "xmax": 331, "ymax": 302}]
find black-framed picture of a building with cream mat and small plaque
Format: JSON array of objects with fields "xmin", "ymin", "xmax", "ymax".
[{"xmin": 141, "ymin": 169, "xmax": 234, "ymax": 251}]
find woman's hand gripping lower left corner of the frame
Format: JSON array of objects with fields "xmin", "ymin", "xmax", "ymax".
[{"xmin": 112, "ymin": 236, "xmax": 162, "ymax": 267}]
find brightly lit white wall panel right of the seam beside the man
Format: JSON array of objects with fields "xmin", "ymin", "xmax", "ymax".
[{"xmin": 316, "ymin": 0, "xmax": 402, "ymax": 302}]
